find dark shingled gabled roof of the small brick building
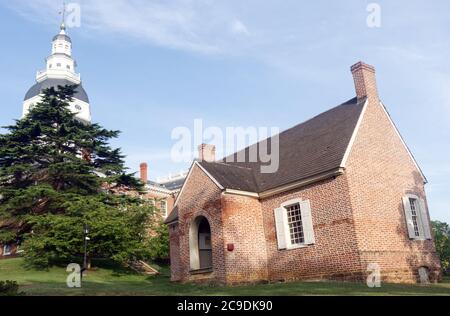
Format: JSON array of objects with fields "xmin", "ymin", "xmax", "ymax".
[{"xmin": 200, "ymin": 98, "xmax": 366, "ymax": 193}]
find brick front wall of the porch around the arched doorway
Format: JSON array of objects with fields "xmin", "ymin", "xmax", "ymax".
[{"xmin": 170, "ymin": 165, "xmax": 225, "ymax": 283}]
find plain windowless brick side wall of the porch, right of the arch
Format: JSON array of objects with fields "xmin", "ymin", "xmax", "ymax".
[{"xmin": 222, "ymin": 194, "xmax": 268, "ymax": 284}]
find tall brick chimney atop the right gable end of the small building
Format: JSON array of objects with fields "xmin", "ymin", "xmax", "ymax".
[{"xmin": 351, "ymin": 62, "xmax": 379, "ymax": 101}]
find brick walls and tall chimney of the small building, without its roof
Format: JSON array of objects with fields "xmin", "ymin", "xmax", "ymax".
[{"xmin": 166, "ymin": 63, "xmax": 441, "ymax": 284}]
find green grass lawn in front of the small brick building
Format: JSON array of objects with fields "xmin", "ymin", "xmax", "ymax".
[{"xmin": 0, "ymin": 259, "xmax": 450, "ymax": 296}]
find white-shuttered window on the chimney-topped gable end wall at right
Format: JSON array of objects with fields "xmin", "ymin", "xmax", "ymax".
[{"xmin": 403, "ymin": 194, "xmax": 432, "ymax": 240}]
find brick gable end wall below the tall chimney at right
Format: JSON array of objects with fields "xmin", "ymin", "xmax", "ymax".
[{"xmin": 346, "ymin": 99, "xmax": 440, "ymax": 282}]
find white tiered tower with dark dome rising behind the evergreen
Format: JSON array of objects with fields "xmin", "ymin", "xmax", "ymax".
[{"xmin": 23, "ymin": 22, "xmax": 91, "ymax": 123}]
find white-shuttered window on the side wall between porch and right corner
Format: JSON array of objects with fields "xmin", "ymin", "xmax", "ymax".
[{"xmin": 274, "ymin": 199, "xmax": 315, "ymax": 250}]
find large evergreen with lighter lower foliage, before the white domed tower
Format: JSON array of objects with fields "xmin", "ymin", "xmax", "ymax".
[{"xmin": 0, "ymin": 86, "xmax": 152, "ymax": 266}]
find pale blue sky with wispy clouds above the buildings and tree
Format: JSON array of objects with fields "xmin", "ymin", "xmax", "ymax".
[{"xmin": 0, "ymin": 0, "xmax": 450, "ymax": 222}]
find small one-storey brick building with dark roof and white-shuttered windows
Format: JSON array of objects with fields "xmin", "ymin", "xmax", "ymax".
[{"xmin": 166, "ymin": 63, "xmax": 441, "ymax": 284}]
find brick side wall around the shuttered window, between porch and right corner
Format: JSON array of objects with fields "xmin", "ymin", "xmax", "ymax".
[{"xmin": 262, "ymin": 175, "xmax": 361, "ymax": 281}]
